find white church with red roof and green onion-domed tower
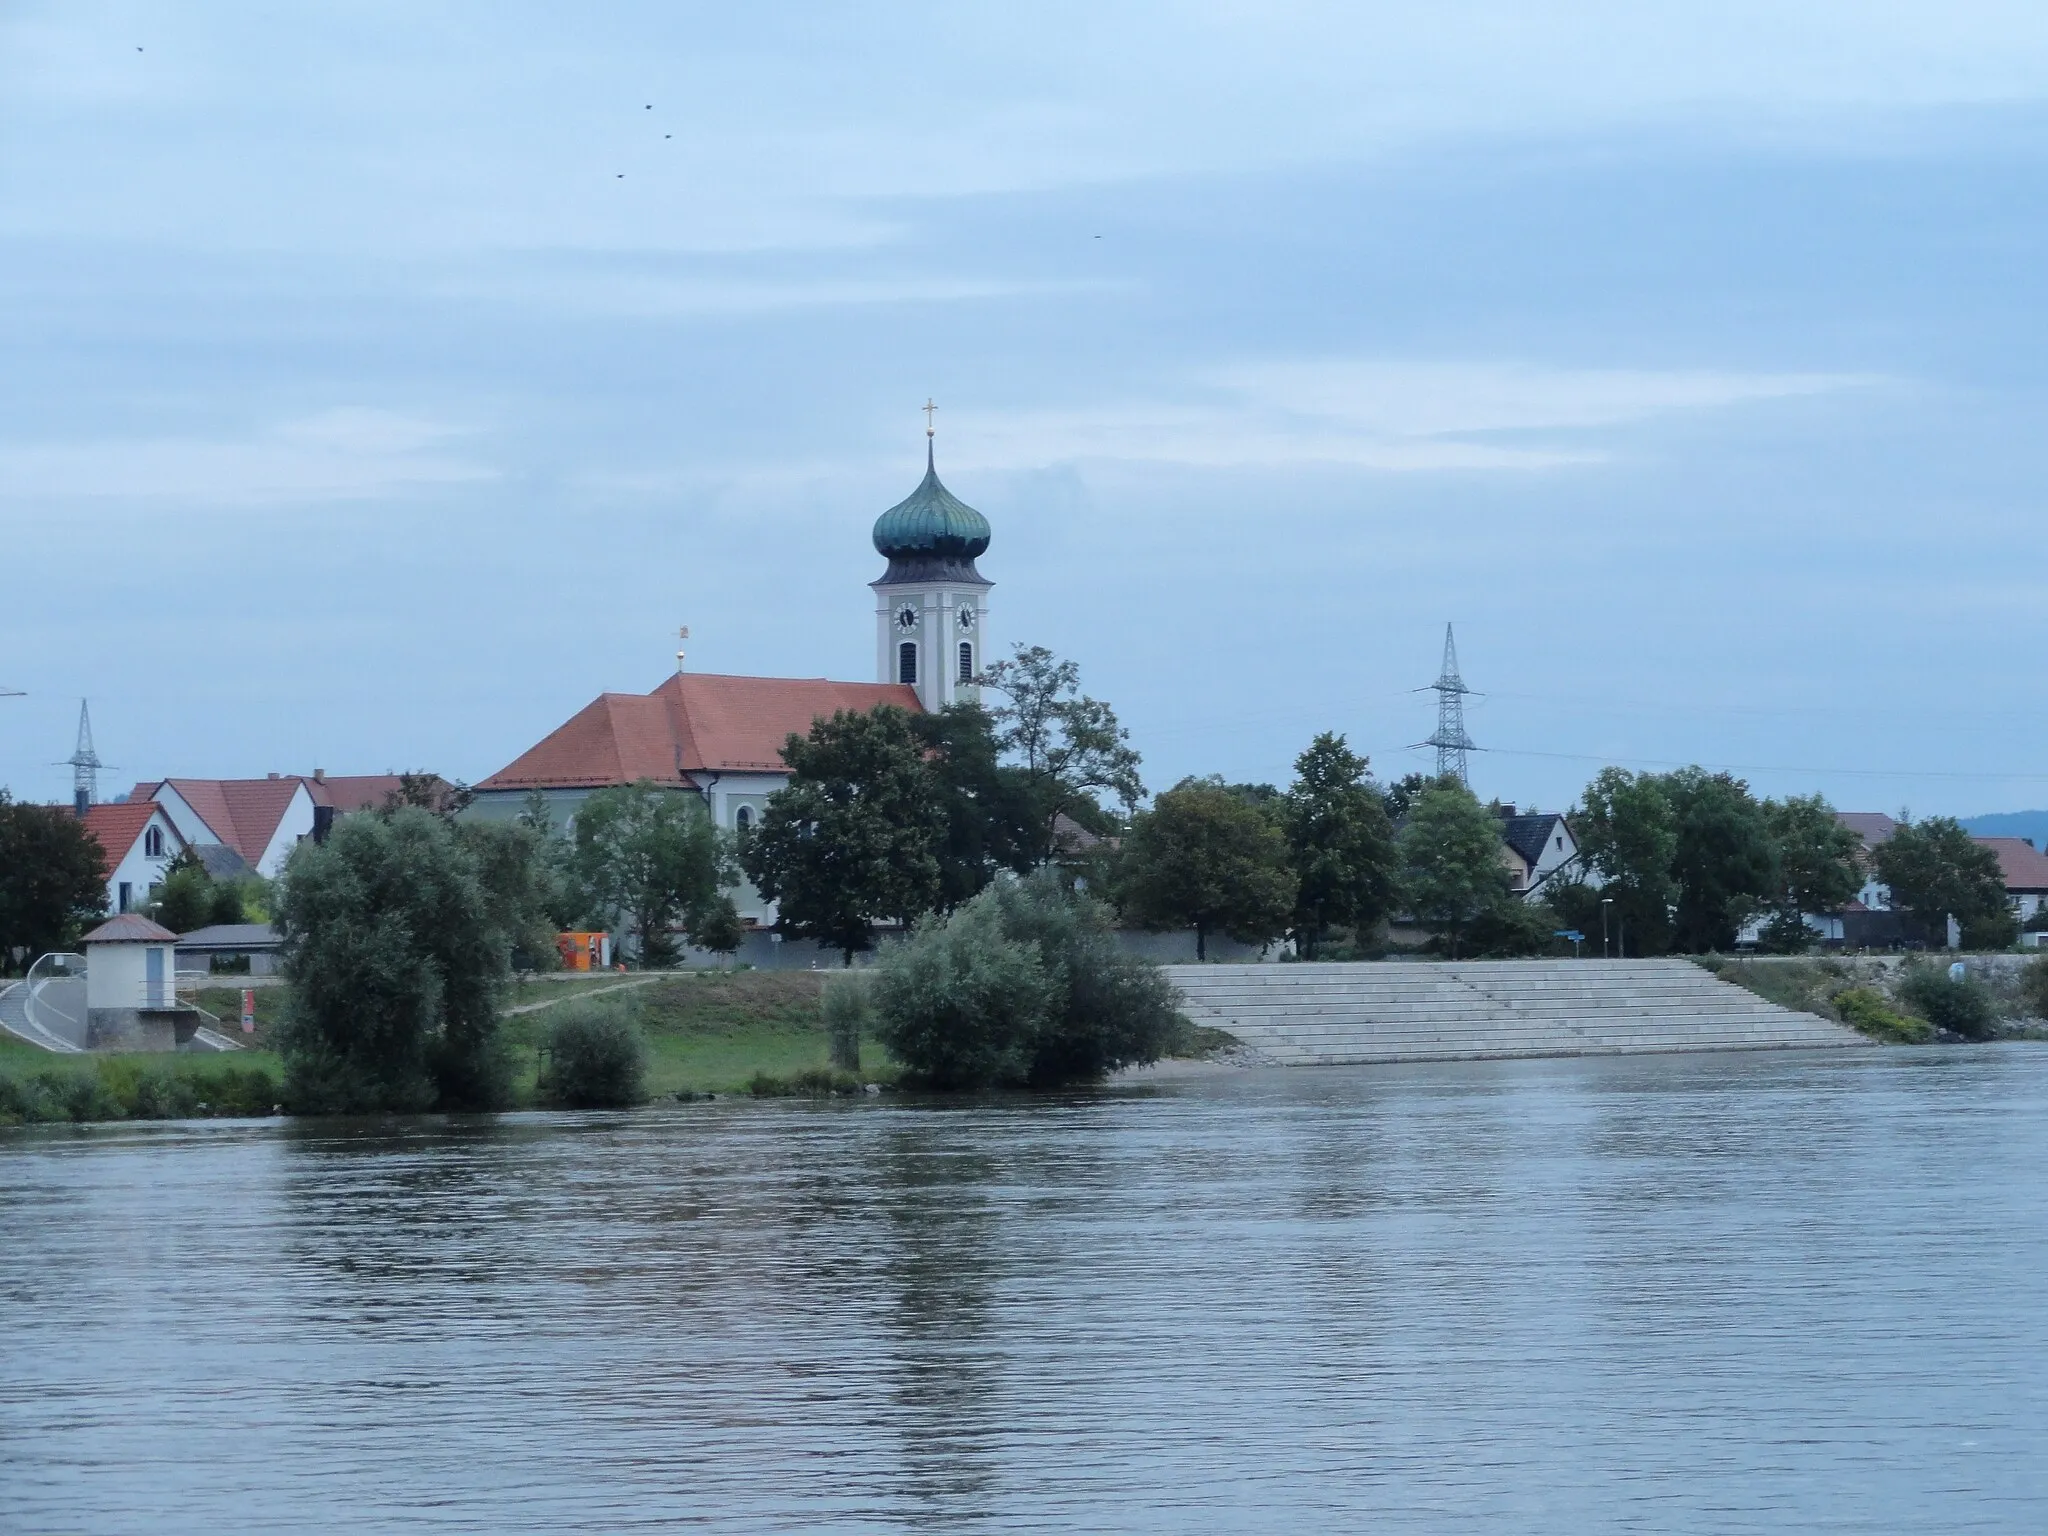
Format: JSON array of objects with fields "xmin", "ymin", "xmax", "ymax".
[{"xmin": 467, "ymin": 428, "xmax": 993, "ymax": 926}]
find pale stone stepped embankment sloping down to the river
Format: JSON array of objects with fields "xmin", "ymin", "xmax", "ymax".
[{"xmin": 1167, "ymin": 961, "xmax": 1870, "ymax": 1067}]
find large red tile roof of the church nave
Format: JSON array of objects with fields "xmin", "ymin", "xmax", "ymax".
[{"xmin": 477, "ymin": 672, "xmax": 922, "ymax": 788}]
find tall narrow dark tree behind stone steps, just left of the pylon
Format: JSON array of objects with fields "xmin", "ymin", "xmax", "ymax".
[{"xmin": 1280, "ymin": 731, "xmax": 1395, "ymax": 958}]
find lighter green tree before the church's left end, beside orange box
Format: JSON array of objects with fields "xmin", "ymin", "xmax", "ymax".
[{"xmin": 575, "ymin": 778, "xmax": 733, "ymax": 971}]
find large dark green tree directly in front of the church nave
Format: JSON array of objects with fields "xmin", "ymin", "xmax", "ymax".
[{"xmin": 739, "ymin": 705, "xmax": 946, "ymax": 965}]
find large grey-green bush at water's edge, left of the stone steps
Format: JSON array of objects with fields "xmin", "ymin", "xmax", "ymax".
[{"xmin": 872, "ymin": 870, "xmax": 1180, "ymax": 1087}]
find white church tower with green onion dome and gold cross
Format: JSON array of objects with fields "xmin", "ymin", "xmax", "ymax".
[{"xmin": 870, "ymin": 428, "xmax": 991, "ymax": 711}]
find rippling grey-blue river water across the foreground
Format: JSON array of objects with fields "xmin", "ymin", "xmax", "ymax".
[{"xmin": 0, "ymin": 1047, "xmax": 2048, "ymax": 1532}]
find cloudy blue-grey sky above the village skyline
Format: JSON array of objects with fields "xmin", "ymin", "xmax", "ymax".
[{"xmin": 0, "ymin": 0, "xmax": 2048, "ymax": 815}]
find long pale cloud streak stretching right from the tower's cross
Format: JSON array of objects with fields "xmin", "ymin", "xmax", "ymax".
[{"xmin": 952, "ymin": 358, "xmax": 1876, "ymax": 471}]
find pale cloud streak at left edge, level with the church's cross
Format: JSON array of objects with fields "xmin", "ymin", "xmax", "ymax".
[{"xmin": 0, "ymin": 408, "xmax": 496, "ymax": 506}]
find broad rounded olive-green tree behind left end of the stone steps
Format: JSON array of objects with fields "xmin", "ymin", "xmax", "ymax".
[{"xmin": 1116, "ymin": 778, "xmax": 1296, "ymax": 961}]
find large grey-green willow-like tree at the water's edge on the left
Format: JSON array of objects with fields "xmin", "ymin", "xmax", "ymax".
[{"xmin": 276, "ymin": 807, "xmax": 510, "ymax": 1114}]
